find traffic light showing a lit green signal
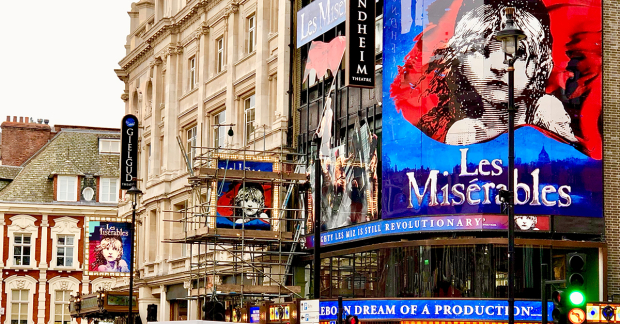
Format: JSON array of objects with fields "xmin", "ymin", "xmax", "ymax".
[{"xmin": 566, "ymin": 253, "xmax": 586, "ymax": 312}]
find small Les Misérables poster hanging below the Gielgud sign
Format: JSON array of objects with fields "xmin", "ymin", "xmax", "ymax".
[{"xmin": 88, "ymin": 221, "xmax": 131, "ymax": 273}]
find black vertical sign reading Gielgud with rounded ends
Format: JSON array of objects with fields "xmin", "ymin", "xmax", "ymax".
[{"xmin": 121, "ymin": 115, "xmax": 138, "ymax": 190}]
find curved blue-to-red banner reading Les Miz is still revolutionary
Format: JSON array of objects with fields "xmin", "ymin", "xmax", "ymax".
[{"xmin": 306, "ymin": 215, "xmax": 550, "ymax": 248}]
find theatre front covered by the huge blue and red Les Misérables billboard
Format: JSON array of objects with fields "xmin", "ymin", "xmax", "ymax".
[{"xmin": 296, "ymin": 0, "xmax": 608, "ymax": 322}]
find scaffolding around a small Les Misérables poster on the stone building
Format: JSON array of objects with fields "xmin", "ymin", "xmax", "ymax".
[{"xmin": 165, "ymin": 141, "xmax": 307, "ymax": 310}]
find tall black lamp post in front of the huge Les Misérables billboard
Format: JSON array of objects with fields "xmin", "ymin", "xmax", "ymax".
[{"xmin": 495, "ymin": 7, "xmax": 525, "ymax": 324}]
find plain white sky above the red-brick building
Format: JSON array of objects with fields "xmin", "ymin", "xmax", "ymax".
[{"xmin": 0, "ymin": 0, "xmax": 137, "ymax": 128}]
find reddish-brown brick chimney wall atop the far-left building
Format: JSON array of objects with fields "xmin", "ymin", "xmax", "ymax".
[{"xmin": 0, "ymin": 116, "xmax": 52, "ymax": 166}]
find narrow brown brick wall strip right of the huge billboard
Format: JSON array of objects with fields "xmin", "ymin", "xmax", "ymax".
[{"xmin": 603, "ymin": 0, "xmax": 620, "ymax": 295}]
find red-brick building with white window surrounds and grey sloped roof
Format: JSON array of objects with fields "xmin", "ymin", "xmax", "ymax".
[{"xmin": 0, "ymin": 117, "xmax": 126, "ymax": 324}]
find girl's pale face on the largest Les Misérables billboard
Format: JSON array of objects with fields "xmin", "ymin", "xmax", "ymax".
[{"xmin": 461, "ymin": 40, "xmax": 542, "ymax": 104}]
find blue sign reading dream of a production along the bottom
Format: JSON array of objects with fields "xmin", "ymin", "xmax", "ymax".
[{"xmin": 319, "ymin": 299, "xmax": 553, "ymax": 322}]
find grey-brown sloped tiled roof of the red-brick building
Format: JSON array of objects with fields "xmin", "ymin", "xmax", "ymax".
[{"xmin": 0, "ymin": 129, "xmax": 120, "ymax": 202}]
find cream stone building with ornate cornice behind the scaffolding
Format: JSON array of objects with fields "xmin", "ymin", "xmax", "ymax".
[{"xmin": 116, "ymin": 0, "xmax": 291, "ymax": 320}]
